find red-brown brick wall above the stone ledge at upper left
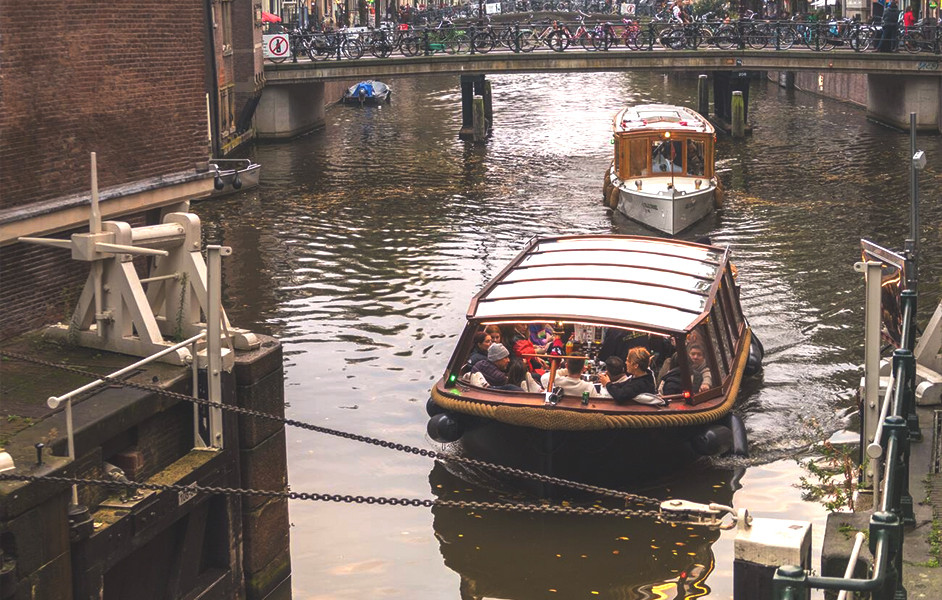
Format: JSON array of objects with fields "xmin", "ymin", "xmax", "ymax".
[{"xmin": 0, "ymin": 0, "xmax": 208, "ymax": 208}]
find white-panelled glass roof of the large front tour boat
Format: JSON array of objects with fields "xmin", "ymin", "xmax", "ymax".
[{"xmin": 468, "ymin": 236, "xmax": 727, "ymax": 331}]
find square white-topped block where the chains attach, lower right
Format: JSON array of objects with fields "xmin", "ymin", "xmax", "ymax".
[{"xmin": 733, "ymin": 511, "xmax": 811, "ymax": 600}]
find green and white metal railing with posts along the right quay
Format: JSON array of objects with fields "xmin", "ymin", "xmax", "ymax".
[{"xmin": 772, "ymin": 113, "xmax": 925, "ymax": 600}]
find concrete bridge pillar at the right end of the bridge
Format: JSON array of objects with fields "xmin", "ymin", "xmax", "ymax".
[{"xmin": 867, "ymin": 72, "xmax": 942, "ymax": 132}]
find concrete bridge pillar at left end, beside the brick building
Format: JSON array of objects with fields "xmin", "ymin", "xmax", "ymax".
[{"xmin": 255, "ymin": 81, "xmax": 325, "ymax": 140}]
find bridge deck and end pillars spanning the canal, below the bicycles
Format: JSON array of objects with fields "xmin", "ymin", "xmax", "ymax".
[{"xmin": 256, "ymin": 49, "xmax": 942, "ymax": 138}]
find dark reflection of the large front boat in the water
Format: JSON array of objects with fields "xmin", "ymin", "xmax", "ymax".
[{"xmin": 429, "ymin": 464, "xmax": 738, "ymax": 600}]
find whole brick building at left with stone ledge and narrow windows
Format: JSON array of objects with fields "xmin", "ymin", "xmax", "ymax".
[{"xmin": 0, "ymin": 0, "xmax": 264, "ymax": 339}]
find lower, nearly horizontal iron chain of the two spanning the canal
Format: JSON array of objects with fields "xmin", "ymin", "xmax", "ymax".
[{"xmin": 0, "ymin": 473, "xmax": 661, "ymax": 520}]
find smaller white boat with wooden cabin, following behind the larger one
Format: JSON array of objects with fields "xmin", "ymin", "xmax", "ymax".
[{"xmin": 602, "ymin": 104, "xmax": 722, "ymax": 235}]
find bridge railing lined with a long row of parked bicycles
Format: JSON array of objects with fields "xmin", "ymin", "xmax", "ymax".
[{"xmin": 264, "ymin": 18, "xmax": 942, "ymax": 62}]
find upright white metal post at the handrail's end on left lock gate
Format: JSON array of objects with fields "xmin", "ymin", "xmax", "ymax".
[{"xmin": 206, "ymin": 245, "xmax": 232, "ymax": 450}]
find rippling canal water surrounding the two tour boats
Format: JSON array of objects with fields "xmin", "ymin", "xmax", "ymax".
[{"xmin": 194, "ymin": 73, "xmax": 942, "ymax": 599}]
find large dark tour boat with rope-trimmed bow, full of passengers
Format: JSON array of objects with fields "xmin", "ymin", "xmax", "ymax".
[{"xmin": 427, "ymin": 235, "xmax": 762, "ymax": 481}]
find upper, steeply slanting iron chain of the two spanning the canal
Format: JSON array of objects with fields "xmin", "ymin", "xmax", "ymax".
[{"xmin": 0, "ymin": 351, "xmax": 660, "ymax": 512}]
